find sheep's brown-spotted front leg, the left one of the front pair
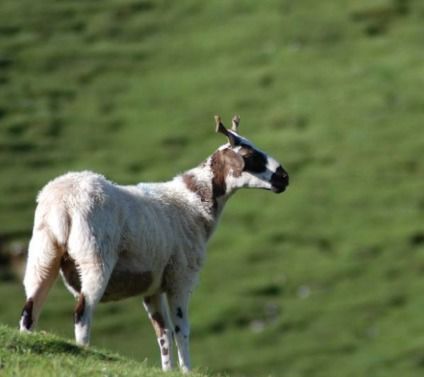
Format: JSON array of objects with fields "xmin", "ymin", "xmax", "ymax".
[{"xmin": 144, "ymin": 294, "xmax": 173, "ymax": 371}]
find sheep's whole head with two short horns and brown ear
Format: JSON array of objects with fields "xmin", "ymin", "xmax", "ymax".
[{"xmin": 212, "ymin": 116, "xmax": 289, "ymax": 195}]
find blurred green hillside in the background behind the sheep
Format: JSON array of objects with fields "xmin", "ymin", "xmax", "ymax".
[{"xmin": 0, "ymin": 0, "xmax": 424, "ymax": 377}]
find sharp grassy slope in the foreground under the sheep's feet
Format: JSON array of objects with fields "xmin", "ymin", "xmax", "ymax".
[{"xmin": 0, "ymin": 325, "xmax": 211, "ymax": 377}]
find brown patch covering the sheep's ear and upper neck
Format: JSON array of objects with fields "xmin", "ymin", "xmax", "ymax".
[{"xmin": 211, "ymin": 149, "xmax": 244, "ymax": 210}]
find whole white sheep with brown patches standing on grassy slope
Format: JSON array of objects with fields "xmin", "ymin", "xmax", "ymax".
[{"xmin": 20, "ymin": 116, "xmax": 289, "ymax": 372}]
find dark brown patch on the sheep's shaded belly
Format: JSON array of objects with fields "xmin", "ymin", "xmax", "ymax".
[{"xmin": 100, "ymin": 270, "xmax": 153, "ymax": 302}]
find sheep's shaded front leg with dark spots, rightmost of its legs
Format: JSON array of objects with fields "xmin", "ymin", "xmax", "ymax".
[{"xmin": 168, "ymin": 291, "xmax": 191, "ymax": 373}]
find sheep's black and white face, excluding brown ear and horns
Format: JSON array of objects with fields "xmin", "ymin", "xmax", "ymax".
[{"xmin": 224, "ymin": 130, "xmax": 289, "ymax": 193}]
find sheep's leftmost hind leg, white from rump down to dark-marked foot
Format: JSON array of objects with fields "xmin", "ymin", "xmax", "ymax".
[{"xmin": 20, "ymin": 201, "xmax": 70, "ymax": 331}]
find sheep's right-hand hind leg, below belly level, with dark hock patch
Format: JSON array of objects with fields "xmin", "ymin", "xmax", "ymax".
[{"xmin": 74, "ymin": 261, "xmax": 115, "ymax": 346}]
